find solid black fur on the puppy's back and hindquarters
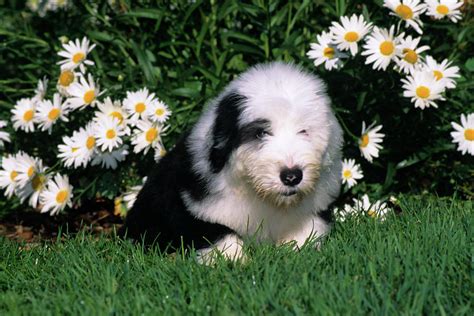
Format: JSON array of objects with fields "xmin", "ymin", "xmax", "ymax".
[{"xmin": 119, "ymin": 135, "xmax": 233, "ymax": 251}]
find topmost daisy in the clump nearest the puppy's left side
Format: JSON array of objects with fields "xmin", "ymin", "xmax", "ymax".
[{"xmin": 123, "ymin": 88, "xmax": 157, "ymax": 125}]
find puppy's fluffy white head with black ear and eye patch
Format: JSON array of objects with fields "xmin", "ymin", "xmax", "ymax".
[{"xmin": 209, "ymin": 63, "xmax": 341, "ymax": 208}]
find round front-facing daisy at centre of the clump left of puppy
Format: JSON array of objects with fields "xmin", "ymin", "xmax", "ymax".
[{"xmin": 94, "ymin": 116, "xmax": 126, "ymax": 151}]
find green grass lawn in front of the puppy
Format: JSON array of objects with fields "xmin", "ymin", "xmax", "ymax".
[{"xmin": 0, "ymin": 198, "xmax": 473, "ymax": 315}]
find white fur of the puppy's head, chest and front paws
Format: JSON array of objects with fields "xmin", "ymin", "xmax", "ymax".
[{"xmin": 181, "ymin": 63, "xmax": 342, "ymax": 254}]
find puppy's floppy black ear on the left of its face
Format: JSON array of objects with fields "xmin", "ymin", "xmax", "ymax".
[{"xmin": 209, "ymin": 92, "xmax": 246, "ymax": 173}]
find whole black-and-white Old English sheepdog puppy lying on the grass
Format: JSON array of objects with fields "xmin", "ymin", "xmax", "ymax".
[{"xmin": 122, "ymin": 62, "xmax": 342, "ymax": 259}]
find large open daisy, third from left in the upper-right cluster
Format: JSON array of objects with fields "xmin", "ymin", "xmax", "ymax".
[{"xmin": 362, "ymin": 25, "xmax": 404, "ymax": 70}]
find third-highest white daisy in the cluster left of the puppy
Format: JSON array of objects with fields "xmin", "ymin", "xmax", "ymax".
[{"xmin": 67, "ymin": 74, "xmax": 105, "ymax": 110}]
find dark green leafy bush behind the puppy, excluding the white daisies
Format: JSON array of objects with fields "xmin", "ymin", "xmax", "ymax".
[{"xmin": 0, "ymin": 0, "xmax": 474, "ymax": 216}]
